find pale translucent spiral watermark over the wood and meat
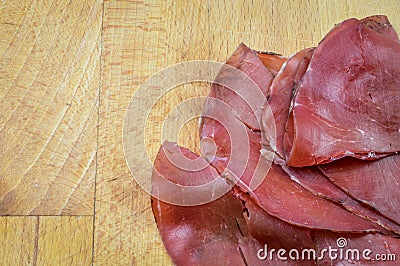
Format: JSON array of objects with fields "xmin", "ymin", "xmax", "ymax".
[{"xmin": 122, "ymin": 61, "xmax": 275, "ymax": 206}]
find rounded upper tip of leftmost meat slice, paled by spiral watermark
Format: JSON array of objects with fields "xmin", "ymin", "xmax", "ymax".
[{"xmin": 152, "ymin": 142, "xmax": 231, "ymax": 206}]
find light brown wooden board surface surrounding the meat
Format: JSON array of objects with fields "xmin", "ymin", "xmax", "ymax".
[{"xmin": 0, "ymin": 0, "xmax": 400, "ymax": 265}]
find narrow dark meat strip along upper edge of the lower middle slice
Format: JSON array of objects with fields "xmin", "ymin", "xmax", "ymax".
[{"xmin": 282, "ymin": 164, "xmax": 400, "ymax": 235}]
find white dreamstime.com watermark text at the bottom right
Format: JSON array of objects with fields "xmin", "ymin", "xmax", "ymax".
[{"xmin": 257, "ymin": 237, "xmax": 396, "ymax": 262}]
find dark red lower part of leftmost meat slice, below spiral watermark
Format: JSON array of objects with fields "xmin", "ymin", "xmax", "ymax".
[{"xmin": 152, "ymin": 185, "xmax": 261, "ymax": 265}]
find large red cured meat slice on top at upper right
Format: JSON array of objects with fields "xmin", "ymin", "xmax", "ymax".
[{"xmin": 286, "ymin": 16, "xmax": 400, "ymax": 167}]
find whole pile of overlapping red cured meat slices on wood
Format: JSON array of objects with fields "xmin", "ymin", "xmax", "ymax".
[{"xmin": 152, "ymin": 16, "xmax": 400, "ymax": 265}]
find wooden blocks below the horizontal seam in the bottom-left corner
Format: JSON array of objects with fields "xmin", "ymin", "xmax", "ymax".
[{"xmin": 0, "ymin": 216, "xmax": 93, "ymax": 265}]
